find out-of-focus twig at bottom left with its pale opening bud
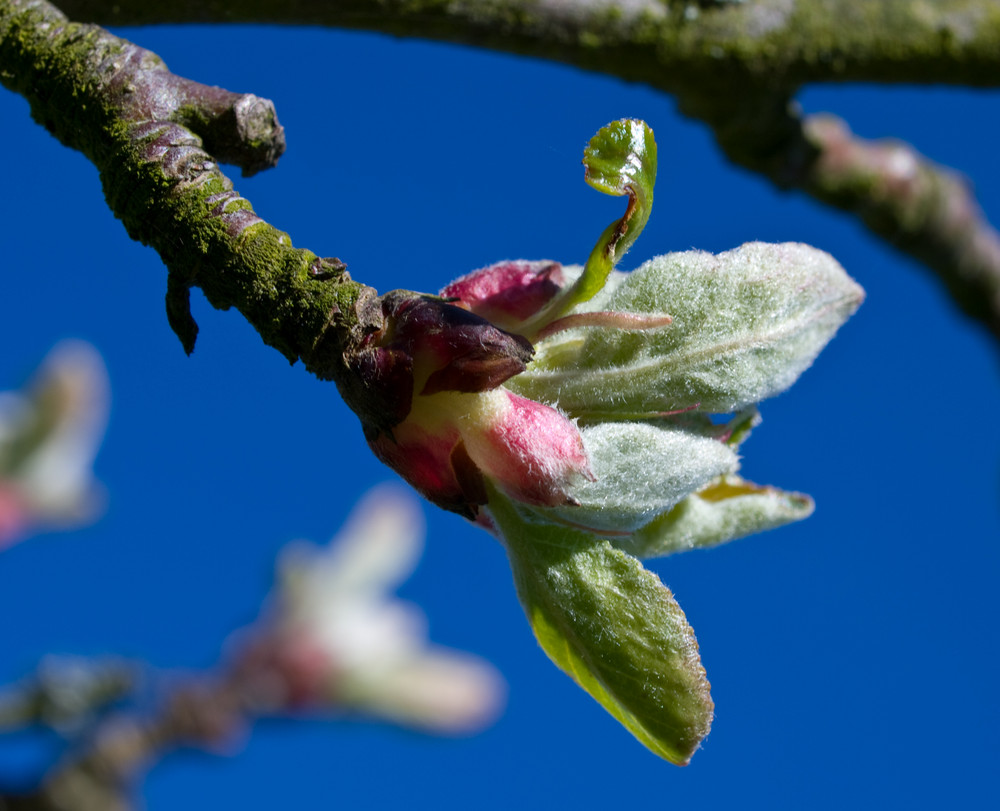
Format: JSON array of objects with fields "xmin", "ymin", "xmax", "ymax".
[{"xmin": 0, "ymin": 487, "xmax": 506, "ymax": 811}]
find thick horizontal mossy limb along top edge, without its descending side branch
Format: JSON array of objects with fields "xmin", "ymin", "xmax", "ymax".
[{"xmin": 48, "ymin": 0, "xmax": 1000, "ymax": 92}]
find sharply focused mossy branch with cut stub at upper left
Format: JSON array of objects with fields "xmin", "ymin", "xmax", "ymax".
[{"xmin": 0, "ymin": 0, "xmax": 375, "ymax": 382}]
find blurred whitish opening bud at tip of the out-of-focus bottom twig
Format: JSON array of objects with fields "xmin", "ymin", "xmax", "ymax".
[{"xmin": 234, "ymin": 487, "xmax": 505, "ymax": 734}]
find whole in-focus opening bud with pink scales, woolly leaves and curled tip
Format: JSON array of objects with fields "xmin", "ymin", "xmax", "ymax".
[{"xmin": 336, "ymin": 121, "xmax": 864, "ymax": 763}]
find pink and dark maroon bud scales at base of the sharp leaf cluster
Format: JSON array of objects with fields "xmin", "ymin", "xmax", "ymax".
[{"xmin": 341, "ymin": 288, "xmax": 592, "ymax": 520}]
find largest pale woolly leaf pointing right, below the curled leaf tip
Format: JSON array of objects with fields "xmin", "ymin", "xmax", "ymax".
[{"xmin": 511, "ymin": 243, "xmax": 864, "ymax": 417}]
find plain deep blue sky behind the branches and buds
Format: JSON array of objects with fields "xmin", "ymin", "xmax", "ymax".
[{"xmin": 0, "ymin": 22, "xmax": 1000, "ymax": 811}]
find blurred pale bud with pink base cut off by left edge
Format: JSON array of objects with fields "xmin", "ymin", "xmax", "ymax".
[{"xmin": 0, "ymin": 341, "xmax": 110, "ymax": 548}]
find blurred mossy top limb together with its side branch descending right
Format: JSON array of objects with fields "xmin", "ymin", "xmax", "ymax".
[{"xmin": 45, "ymin": 0, "xmax": 1000, "ymax": 338}]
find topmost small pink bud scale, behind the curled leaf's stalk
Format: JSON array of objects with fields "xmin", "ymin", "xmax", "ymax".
[{"xmin": 441, "ymin": 259, "xmax": 565, "ymax": 331}]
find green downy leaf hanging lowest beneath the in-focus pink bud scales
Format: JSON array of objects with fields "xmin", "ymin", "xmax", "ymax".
[{"xmin": 490, "ymin": 493, "xmax": 713, "ymax": 765}]
